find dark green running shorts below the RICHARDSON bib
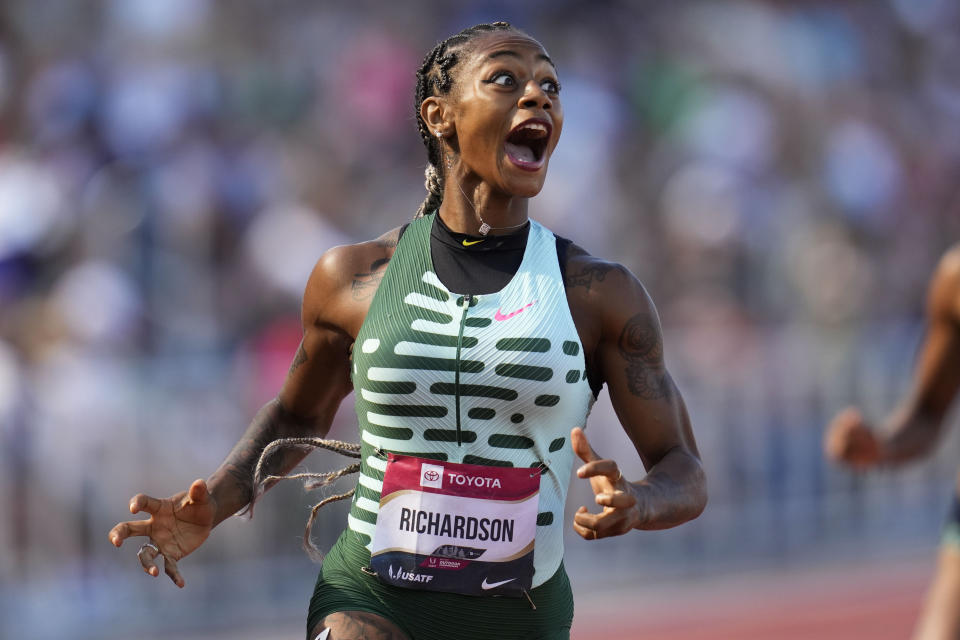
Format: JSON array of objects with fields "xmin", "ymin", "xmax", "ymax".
[{"xmin": 307, "ymin": 529, "xmax": 573, "ymax": 640}]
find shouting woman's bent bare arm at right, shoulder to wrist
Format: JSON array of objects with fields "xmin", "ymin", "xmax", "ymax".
[{"xmin": 596, "ymin": 261, "xmax": 707, "ymax": 529}]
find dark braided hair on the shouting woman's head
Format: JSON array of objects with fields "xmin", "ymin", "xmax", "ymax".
[{"xmin": 413, "ymin": 22, "xmax": 516, "ymax": 218}]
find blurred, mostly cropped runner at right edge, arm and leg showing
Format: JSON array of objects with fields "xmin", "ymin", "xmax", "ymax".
[{"xmin": 824, "ymin": 245, "xmax": 960, "ymax": 640}]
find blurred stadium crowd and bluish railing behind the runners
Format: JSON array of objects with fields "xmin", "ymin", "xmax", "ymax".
[{"xmin": 0, "ymin": 0, "xmax": 960, "ymax": 639}]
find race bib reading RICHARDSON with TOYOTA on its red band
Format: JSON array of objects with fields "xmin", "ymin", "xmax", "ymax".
[{"xmin": 370, "ymin": 453, "xmax": 540, "ymax": 597}]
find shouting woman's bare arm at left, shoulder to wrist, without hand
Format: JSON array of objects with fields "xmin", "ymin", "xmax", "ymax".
[{"xmin": 207, "ymin": 243, "xmax": 369, "ymax": 526}]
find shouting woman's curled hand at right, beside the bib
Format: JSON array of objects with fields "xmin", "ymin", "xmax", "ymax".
[{"xmin": 570, "ymin": 427, "xmax": 640, "ymax": 540}]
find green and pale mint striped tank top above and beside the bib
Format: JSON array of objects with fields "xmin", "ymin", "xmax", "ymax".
[{"xmin": 348, "ymin": 215, "xmax": 594, "ymax": 587}]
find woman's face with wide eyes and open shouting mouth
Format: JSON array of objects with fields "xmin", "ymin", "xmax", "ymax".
[{"xmin": 451, "ymin": 31, "xmax": 563, "ymax": 197}]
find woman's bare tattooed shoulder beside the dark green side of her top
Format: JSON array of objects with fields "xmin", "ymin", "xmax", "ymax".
[{"xmin": 302, "ymin": 227, "xmax": 401, "ymax": 336}]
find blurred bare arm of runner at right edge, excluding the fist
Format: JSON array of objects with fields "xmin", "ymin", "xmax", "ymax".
[{"xmin": 878, "ymin": 247, "xmax": 960, "ymax": 463}]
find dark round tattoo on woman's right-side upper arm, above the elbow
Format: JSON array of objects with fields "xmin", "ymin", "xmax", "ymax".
[{"xmin": 617, "ymin": 313, "xmax": 671, "ymax": 400}]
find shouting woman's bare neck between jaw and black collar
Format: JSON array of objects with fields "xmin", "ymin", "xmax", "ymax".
[{"xmin": 438, "ymin": 172, "xmax": 528, "ymax": 235}]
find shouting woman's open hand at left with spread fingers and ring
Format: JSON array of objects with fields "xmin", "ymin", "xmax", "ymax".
[{"xmin": 107, "ymin": 480, "xmax": 216, "ymax": 588}]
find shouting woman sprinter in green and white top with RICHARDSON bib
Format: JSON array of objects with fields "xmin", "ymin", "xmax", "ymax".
[{"xmin": 109, "ymin": 22, "xmax": 706, "ymax": 640}]
